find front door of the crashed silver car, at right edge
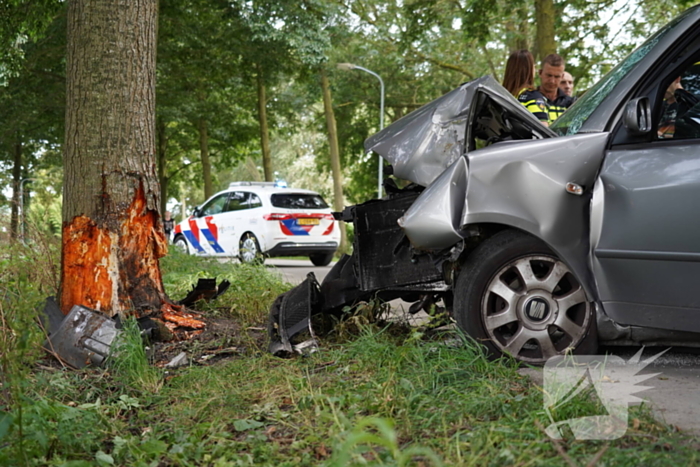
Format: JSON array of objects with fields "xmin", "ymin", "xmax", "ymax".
[{"xmin": 591, "ymin": 44, "xmax": 700, "ymax": 331}]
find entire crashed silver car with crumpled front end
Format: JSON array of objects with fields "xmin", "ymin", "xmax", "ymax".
[{"xmin": 270, "ymin": 7, "xmax": 700, "ymax": 364}]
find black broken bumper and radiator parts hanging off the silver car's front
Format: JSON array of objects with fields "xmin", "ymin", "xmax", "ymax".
[{"xmin": 269, "ymin": 186, "xmax": 451, "ymax": 356}]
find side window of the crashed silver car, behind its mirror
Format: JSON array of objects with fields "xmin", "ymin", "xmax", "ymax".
[{"xmin": 656, "ymin": 60, "xmax": 700, "ymax": 140}]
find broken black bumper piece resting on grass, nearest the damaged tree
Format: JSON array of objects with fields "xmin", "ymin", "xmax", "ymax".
[{"xmin": 268, "ymin": 272, "xmax": 320, "ymax": 357}]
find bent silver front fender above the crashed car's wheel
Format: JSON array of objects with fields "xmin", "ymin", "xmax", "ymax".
[{"xmin": 400, "ymin": 133, "xmax": 608, "ymax": 297}]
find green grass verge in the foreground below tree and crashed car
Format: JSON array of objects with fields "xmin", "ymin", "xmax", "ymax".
[{"xmin": 0, "ymin": 239, "xmax": 700, "ymax": 466}]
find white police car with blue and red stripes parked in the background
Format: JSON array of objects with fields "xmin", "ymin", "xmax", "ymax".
[{"xmin": 173, "ymin": 182, "xmax": 340, "ymax": 266}]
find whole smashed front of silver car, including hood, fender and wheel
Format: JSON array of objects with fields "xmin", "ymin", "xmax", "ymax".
[{"xmin": 269, "ymin": 77, "xmax": 688, "ymax": 364}]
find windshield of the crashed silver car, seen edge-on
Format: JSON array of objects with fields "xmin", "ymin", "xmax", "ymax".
[{"xmin": 550, "ymin": 11, "xmax": 686, "ymax": 136}]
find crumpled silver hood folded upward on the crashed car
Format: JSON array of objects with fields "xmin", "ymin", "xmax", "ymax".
[{"xmin": 365, "ymin": 76, "xmax": 556, "ymax": 187}]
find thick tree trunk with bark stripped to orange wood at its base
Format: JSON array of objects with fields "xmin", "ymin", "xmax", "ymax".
[{"xmin": 59, "ymin": 0, "xmax": 168, "ymax": 316}]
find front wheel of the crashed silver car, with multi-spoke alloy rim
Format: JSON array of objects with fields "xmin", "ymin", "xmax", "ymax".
[{"xmin": 454, "ymin": 230, "xmax": 597, "ymax": 365}]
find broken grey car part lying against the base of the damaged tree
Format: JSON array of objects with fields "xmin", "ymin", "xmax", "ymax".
[{"xmin": 44, "ymin": 305, "xmax": 121, "ymax": 368}]
